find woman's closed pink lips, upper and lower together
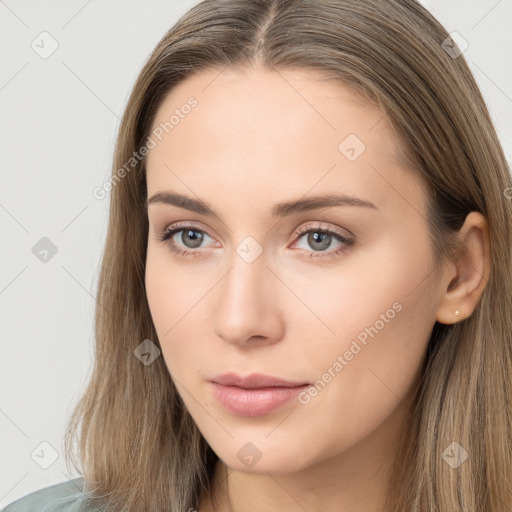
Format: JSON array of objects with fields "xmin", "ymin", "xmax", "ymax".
[{"xmin": 210, "ymin": 373, "xmax": 310, "ymax": 418}]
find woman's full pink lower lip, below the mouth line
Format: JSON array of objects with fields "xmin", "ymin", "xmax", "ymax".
[{"xmin": 211, "ymin": 382, "xmax": 309, "ymax": 418}]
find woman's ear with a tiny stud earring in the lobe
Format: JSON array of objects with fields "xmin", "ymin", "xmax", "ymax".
[{"xmin": 436, "ymin": 212, "xmax": 490, "ymax": 324}]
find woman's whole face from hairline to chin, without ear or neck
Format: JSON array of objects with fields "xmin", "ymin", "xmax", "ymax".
[{"xmin": 146, "ymin": 70, "xmax": 442, "ymax": 473}]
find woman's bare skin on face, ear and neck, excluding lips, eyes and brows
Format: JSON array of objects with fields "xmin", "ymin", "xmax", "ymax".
[{"xmin": 146, "ymin": 68, "xmax": 489, "ymax": 512}]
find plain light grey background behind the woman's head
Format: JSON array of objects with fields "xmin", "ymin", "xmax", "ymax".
[{"xmin": 0, "ymin": 0, "xmax": 512, "ymax": 508}]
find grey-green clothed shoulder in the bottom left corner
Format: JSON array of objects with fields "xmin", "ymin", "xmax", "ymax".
[{"xmin": 1, "ymin": 477, "xmax": 97, "ymax": 512}]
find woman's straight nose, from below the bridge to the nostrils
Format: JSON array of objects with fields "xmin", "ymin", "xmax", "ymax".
[{"xmin": 214, "ymin": 247, "xmax": 284, "ymax": 347}]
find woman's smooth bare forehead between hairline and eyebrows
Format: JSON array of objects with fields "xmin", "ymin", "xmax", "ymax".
[{"xmin": 146, "ymin": 69, "xmax": 424, "ymax": 220}]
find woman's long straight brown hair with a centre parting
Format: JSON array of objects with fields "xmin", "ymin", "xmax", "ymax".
[{"xmin": 65, "ymin": 0, "xmax": 512, "ymax": 512}]
